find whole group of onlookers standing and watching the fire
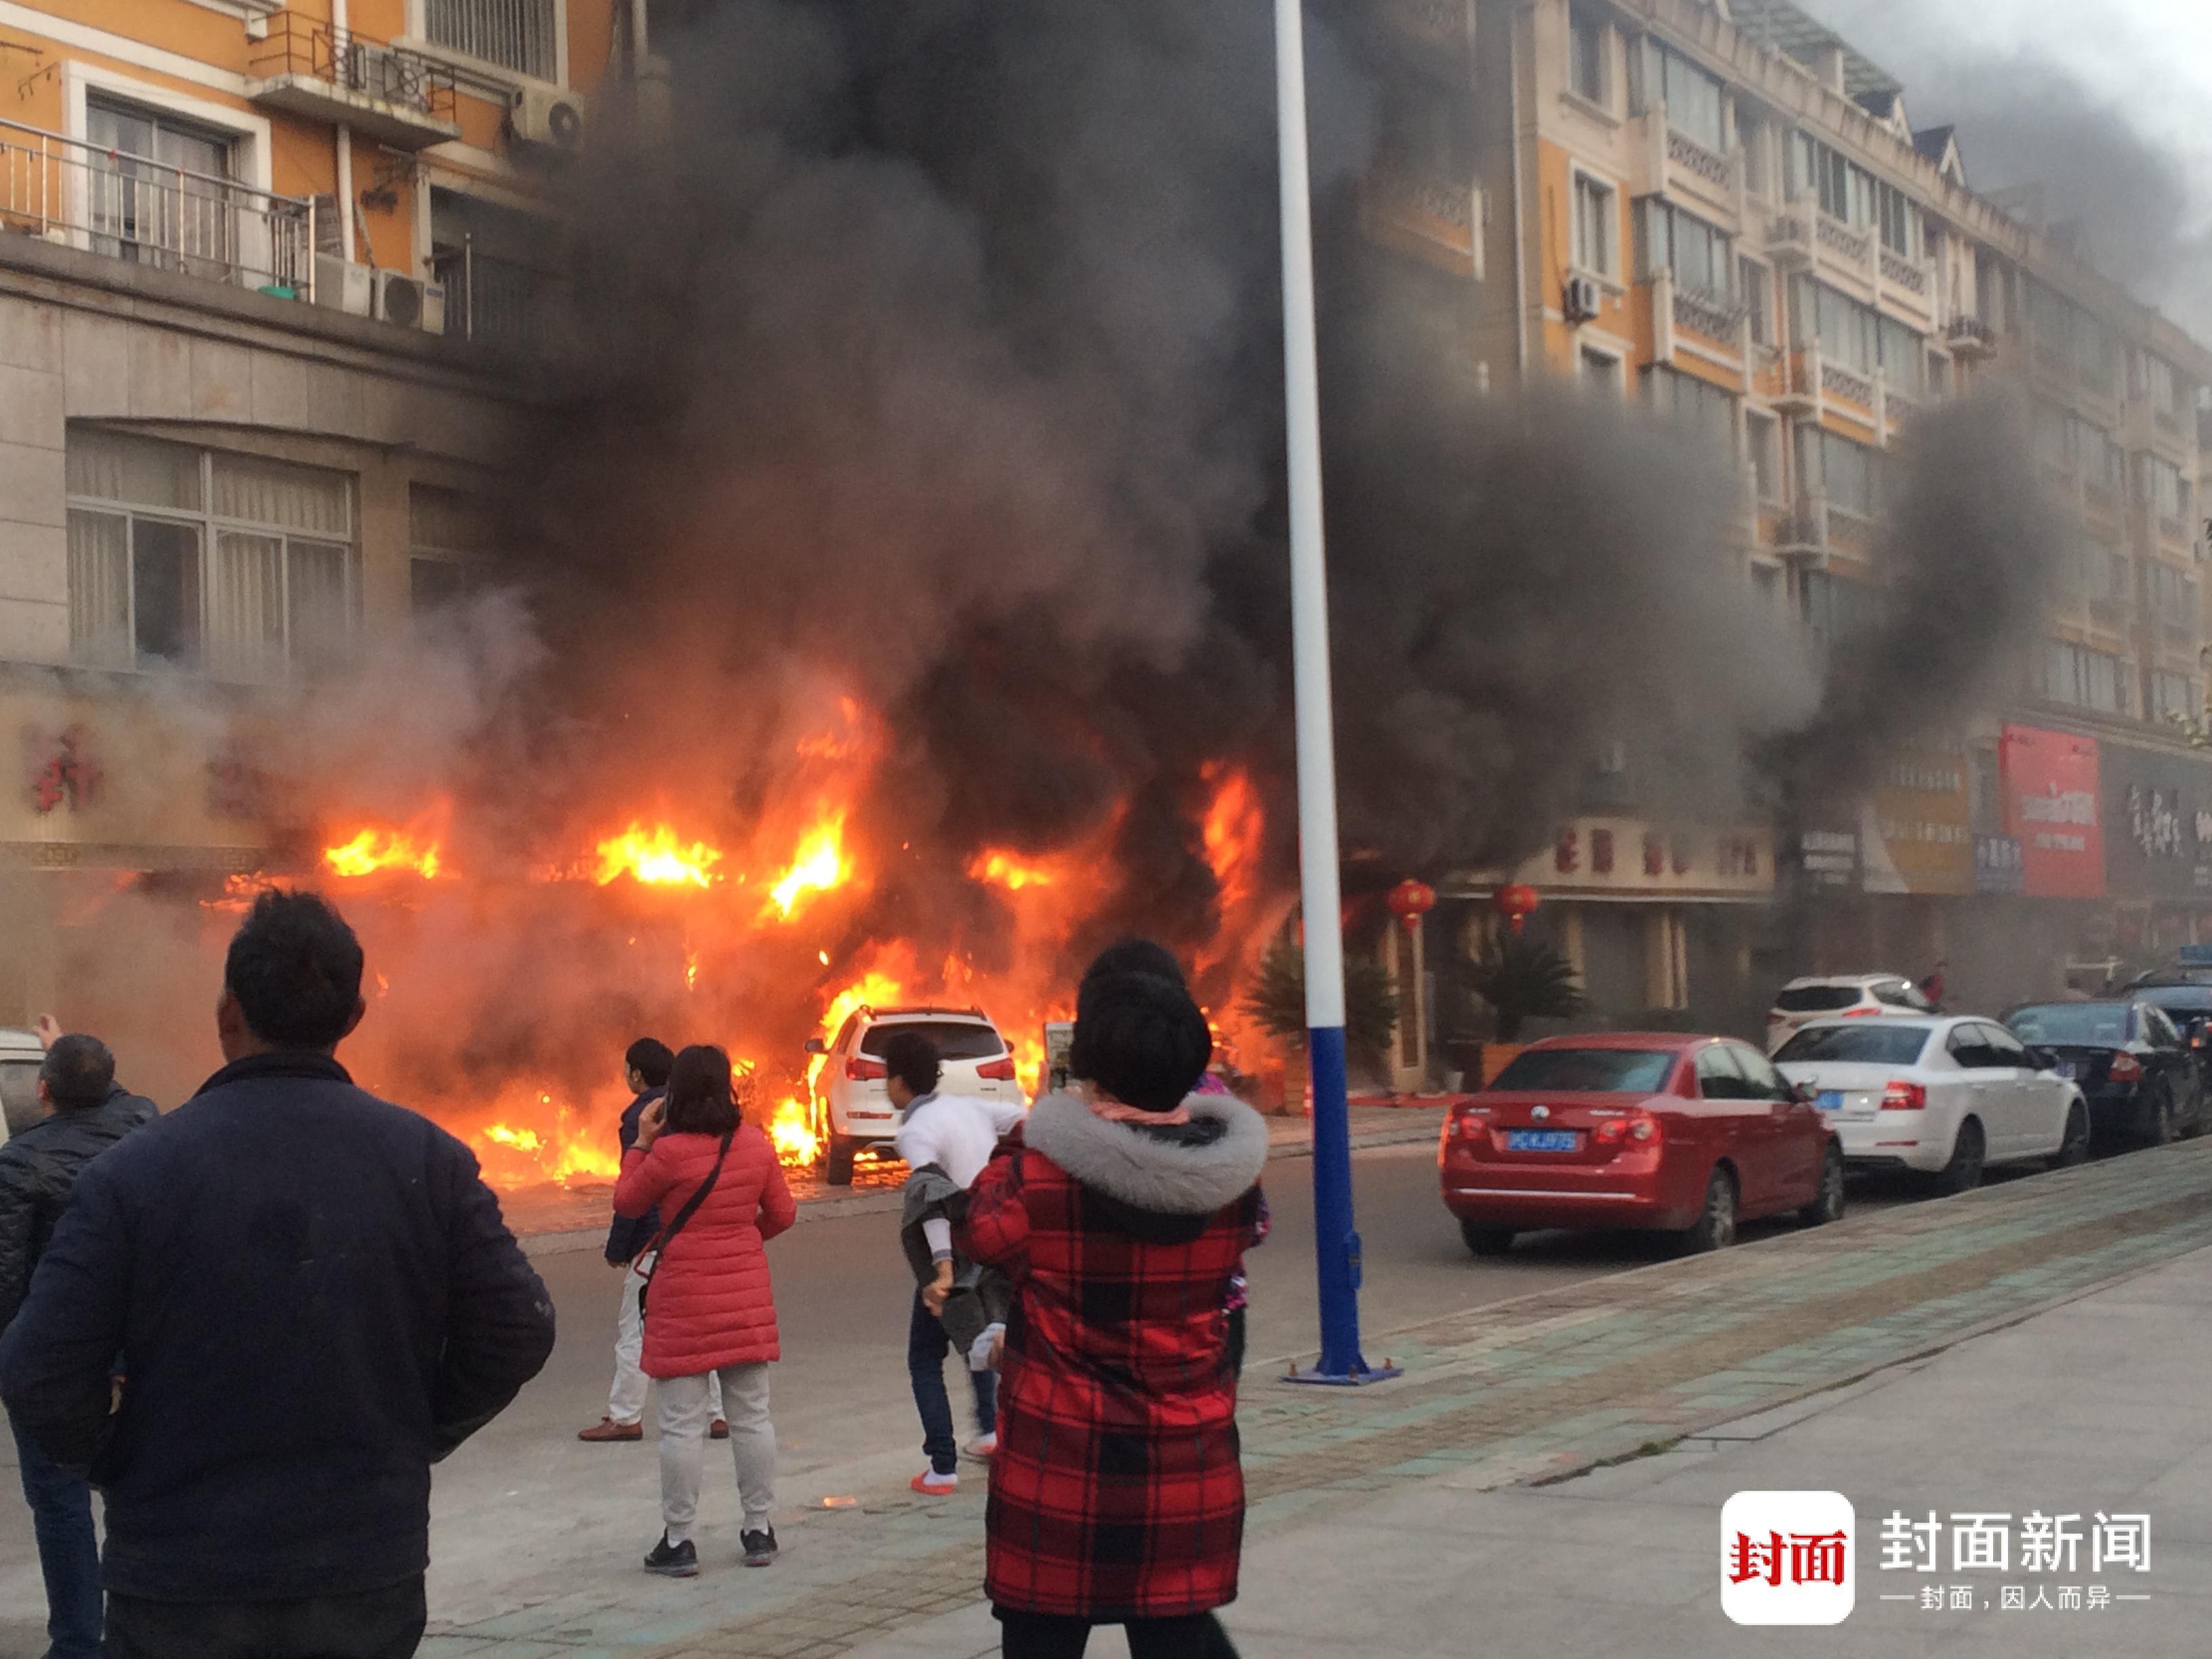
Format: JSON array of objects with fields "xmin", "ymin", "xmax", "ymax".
[{"xmin": 0, "ymin": 891, "xmax": 1267, "ymax": 1659}]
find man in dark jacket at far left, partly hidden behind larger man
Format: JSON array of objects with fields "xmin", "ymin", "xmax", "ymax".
[{"xmin": 0, "ymin": 1022, "xmax": 155, "ymax": 1659}]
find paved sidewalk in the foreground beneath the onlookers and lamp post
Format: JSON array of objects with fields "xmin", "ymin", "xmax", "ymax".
[{"xmin": 425, "ymin": 1141, "xmax": 2212, "ymax": 1659}]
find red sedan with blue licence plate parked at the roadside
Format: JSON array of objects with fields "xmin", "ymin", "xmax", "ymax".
[{"xmin": 1438, "ymin": 1033, "xmax": 1843, "ymax": 1256}]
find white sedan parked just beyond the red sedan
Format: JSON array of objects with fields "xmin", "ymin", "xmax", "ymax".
[{"xmin": 1774, "ymin": 1017, "xmax": 2088, "ymax": 1192}]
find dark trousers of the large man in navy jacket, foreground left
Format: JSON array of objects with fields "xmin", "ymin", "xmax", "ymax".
[{"xmin": 108, "ymin": 1579, "xmax": 427, "ymax": 1659}]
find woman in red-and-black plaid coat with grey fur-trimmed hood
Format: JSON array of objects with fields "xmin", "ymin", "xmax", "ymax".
[{"xmin": 960, "ymin": 973, "xmax": 1267, "ymax": 1659}]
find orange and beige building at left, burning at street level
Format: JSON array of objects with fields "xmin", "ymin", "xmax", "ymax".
[{"xmin": 0, "ymin": 0, "xmax": 646, "ymax": 1022}]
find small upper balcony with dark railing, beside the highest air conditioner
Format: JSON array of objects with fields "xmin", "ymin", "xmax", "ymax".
[{"xmin": 248, "ymin": 11, "xmax": 460, "ymax": 150}]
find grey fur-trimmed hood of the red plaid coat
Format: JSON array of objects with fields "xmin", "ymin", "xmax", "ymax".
[{"xmin": 1022, "ymin": 1095, "xmax": 1267, "ymax": 1216}]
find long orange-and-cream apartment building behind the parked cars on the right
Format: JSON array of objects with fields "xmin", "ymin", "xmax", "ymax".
[{"xmin": 1363, "ymin": 0, "xmax": 2212, "ymax": 1040}]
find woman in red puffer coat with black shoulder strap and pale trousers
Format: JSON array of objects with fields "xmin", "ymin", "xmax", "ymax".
[{"xmin": 615, "ymin": 1046, "xmax": 798, "ymax": 1579}]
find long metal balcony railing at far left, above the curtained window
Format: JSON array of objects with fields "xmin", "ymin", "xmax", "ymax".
[{"xmin": 0, "ymin": 119, "xmax": 314, "ymax": 299}]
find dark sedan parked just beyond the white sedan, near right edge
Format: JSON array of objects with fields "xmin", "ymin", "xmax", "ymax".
[{"xmin": 2004, "ymin": 998, "xmax": 2205, "ymax": 1146}]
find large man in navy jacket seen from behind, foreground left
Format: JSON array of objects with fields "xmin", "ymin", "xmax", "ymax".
[{"xmin": 0, "ymin": 891, "xmax": 553, "ymax": 1659}]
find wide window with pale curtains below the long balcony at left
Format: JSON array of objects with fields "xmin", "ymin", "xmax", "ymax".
[{"xmin": 66, "ymin": 429, "xmax": 361, "ymax": 681}]
